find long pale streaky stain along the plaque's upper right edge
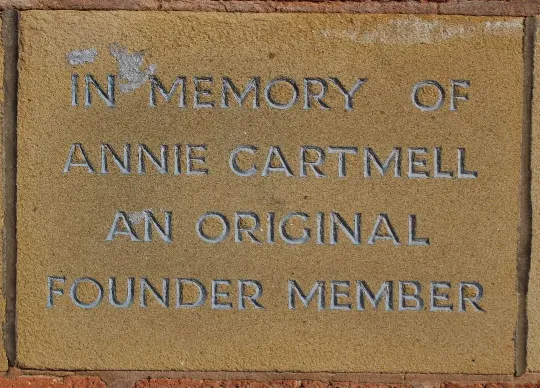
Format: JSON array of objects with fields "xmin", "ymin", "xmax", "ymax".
[{"xmin": 321, "ymin": 16, "xmax": 523, "ymax": 44}]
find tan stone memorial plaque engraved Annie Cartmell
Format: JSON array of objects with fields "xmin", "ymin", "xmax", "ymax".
[{"xmin": 17, "ymin": 11, "xmax": 523, "ymax": 373}]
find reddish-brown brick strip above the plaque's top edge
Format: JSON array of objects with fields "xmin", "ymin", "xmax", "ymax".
[{"xmin": 0, "ymin": 0, "xmax": 540, "ymax": 16}]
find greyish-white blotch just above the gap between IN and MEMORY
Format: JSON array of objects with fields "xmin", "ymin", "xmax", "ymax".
[{"xmin": 109, "ymin": 43, "xmax": 157, "ymax": 93}]
